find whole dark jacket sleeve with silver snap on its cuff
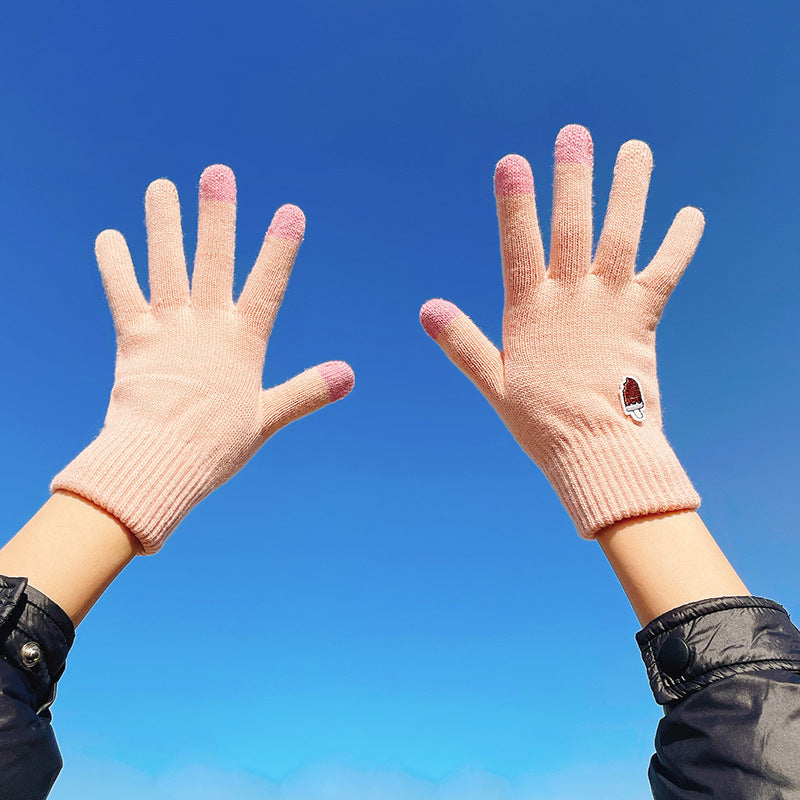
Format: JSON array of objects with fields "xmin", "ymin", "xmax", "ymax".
[{"xmin": 0, "ymin": 575, "xmax": 75, "ymax": 800}]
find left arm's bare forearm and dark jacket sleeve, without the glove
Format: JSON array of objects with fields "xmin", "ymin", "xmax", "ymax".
[{"xmin": 0, "ymin": 492, "xmax": 138, "ymax": 800}]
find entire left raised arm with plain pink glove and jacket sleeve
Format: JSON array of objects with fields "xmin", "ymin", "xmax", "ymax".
[{"xmin": 0, "ymin": 165, "xmax": 354, "ymax": 800}]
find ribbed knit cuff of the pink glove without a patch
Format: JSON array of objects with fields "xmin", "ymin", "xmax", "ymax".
[{"xmin": 50, "ymin": 427, "xmax": 220, "ymax": 555}]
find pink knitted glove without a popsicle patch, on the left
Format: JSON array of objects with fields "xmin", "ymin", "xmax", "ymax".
[{"xmin": 50, "ymin": 164, "xmax": 354, "ymax": 553}]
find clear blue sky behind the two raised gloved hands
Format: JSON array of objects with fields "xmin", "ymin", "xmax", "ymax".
[{"xmin": 0, "ymin": 0, "xmax": 800, "ymax": 800}]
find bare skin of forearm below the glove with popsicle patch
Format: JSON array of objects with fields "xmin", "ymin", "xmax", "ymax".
[{"xmin": 597, "ymin": 511, "xmax": 750, "ymax": 626}]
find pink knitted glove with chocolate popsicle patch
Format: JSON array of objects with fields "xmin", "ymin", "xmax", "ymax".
[{"xmin": 420, "ymin": 125, "xmax": 704, "ymax": 539}]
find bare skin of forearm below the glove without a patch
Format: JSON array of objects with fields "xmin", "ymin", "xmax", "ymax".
[{"xmin": 0, "ymin": 491, "xmax": 141, "ymax": 626}]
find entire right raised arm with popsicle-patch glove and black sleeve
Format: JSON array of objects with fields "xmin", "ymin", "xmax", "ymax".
[{"xmin": 420, "ymin": 126, "xmax": 800, "ymax": 800}]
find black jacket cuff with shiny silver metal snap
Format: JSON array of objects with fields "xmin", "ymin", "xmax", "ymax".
[{"xmin": 0, "ymin": 575, "xmax": 75, "ymax": 714}]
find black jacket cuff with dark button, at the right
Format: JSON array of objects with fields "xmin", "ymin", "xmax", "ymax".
[{"xmin": 636, "ymin": 596, "xmax": 800, "ymax": 705}]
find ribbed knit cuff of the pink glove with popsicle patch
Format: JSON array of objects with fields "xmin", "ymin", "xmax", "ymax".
[{"xmin": 540, "ymin": 420, "xmax": 700, "ymax": 539}]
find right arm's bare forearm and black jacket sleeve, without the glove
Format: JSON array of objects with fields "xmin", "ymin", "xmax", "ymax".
[{"xmin": 597, "ymin": 512, "xmax": 800, "ymax": 800}]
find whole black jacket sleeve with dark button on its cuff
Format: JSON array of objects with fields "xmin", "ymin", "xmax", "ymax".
[{"xmin": 636, "ymin": 597, "xmax": 800, "ymax": 800}]
